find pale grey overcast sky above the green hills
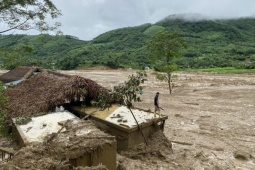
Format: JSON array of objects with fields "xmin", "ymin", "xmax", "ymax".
[{"xmin": 24, "ymin": 0, "xmax": 255, "ymax": 40}]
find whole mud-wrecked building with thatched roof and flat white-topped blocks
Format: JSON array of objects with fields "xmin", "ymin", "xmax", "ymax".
[{"xmin": 0, "ymin": 67, "xmax": 167, "ymax": 169}]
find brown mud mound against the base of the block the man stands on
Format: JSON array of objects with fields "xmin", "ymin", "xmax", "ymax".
[{"xmin": 117, "ymin": 130, "xmax": 173, "ymax": 170}]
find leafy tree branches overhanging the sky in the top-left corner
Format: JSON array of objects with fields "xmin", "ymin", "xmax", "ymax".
[{"xmin": 0, "ymin": 0, "xmax": 61, "ymax": 34}]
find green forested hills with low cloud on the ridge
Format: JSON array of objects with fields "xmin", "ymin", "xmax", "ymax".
[{"xmin": 0, "ymin": 14, "xmax": 255, "ymax": 69}]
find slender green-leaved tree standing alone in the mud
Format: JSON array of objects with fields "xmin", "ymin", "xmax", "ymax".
[{"xmin": 146, "ymin": 31, "xmax": 187, "ymax": 94}]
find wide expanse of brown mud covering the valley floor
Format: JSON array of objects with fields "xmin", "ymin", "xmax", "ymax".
[{"xmin": 0, "ymin": 69, "xmax": 255, "ymax": 170}]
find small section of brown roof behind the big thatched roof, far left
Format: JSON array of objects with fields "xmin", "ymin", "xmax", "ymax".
[{"xmin": 0, "ymin": 66, "xmax": 40, "ymax": 83}]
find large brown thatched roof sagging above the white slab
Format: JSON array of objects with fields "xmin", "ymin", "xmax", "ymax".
[{"xmin": 6, "ymin": 71, "xmax": 106, "ymax": 125}]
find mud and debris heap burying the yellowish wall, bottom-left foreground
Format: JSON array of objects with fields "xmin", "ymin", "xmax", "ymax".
[{"xmin": 3, "ymin": 120, "xmax": 116, "ymax": 170}]
